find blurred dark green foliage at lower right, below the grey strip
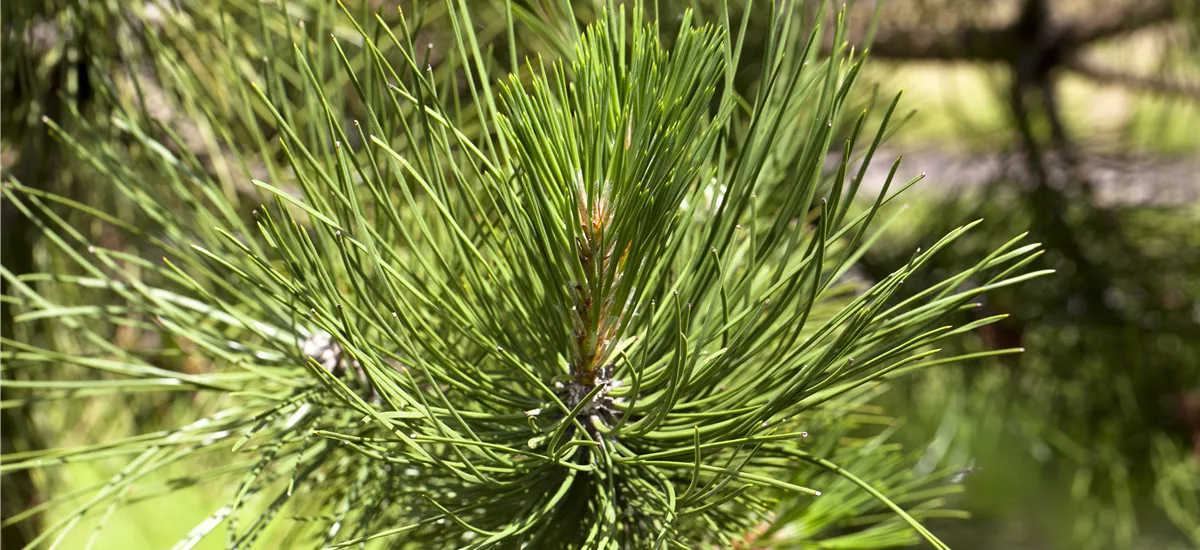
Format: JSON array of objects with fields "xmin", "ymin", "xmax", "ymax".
[{"xmin": 865, "ymin": 188, "xmax": 1200, "ymax": 549}]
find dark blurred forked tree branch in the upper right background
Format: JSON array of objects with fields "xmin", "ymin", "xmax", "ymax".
[{"xmin": 835, "ymin": 0, "xmax": 1200, "ymax": 329}]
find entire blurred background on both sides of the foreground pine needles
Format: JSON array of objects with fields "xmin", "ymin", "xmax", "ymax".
[{"xmin": 0, "ymin": 0, "xmax": 1200, "ymax": 549}]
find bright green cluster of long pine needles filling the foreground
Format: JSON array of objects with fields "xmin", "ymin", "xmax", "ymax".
[{"xmin": 0, "ymin": 1, "xmax": 1040, "ymax": 548}]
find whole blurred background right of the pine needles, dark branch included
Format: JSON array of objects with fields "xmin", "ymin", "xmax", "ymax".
[{"xmin": 849, "ymin": 0, "xmax": 1200, "ymax": 549}]
